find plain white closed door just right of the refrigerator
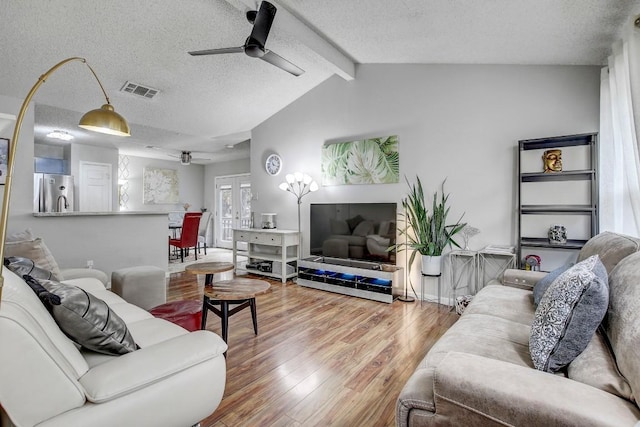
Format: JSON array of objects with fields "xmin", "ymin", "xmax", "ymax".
[{"xmin": 78, "ymin": 162, "xmax": 113, "ymax": 212}]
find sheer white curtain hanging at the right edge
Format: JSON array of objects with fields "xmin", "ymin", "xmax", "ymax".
[{"xmin": 600, "ymin": 16, "xmax": 640, "ymax": 236}]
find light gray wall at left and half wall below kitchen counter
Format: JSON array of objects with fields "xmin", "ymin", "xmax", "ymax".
[{"xmin": 0, "ymin": 93, "xmax": 168, "ymax": 274}]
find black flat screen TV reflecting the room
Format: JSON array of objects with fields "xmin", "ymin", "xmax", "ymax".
[{"xmin": 310, "ymin": 203, "xmax": 397, "ymax": 264}]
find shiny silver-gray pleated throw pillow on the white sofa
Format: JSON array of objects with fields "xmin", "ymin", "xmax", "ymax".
[{"xmin": 25, "ymin": 276, "xmax": 138, "ymax": 355}]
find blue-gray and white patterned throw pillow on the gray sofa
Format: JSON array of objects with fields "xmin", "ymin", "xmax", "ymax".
[{"xmin": 529, "ymin": 255, "xmax": 609, "ymax": 372}]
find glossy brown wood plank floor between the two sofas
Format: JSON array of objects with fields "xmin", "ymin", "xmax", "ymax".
[{"xmin": 168, "ymin": 273, "xmax": 458, "ymax": 427}]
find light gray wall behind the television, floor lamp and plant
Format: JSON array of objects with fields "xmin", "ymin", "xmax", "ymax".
[{"xmin": 251, "ymin": 65, "xmax": 600, "ymax": 294}]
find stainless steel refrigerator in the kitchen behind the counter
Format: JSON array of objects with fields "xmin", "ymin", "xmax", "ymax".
[{"xmin": 33, "ymin": 173, "xmax": 73, "ymax": 212}]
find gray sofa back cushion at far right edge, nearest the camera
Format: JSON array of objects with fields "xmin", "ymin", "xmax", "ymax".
[{"xmin": 603, "ymin": 252, "xmax": 640, "ymax": 406}]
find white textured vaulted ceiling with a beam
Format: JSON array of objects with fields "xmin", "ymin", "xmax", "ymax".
[{"xmin": 0, "ymin": 0, "xmax": 640, "ymax": 163}]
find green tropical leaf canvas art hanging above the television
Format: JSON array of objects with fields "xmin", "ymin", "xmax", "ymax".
[{"xmin": 322, "ymin": 135, "xmax": 400, "ymax": 185}]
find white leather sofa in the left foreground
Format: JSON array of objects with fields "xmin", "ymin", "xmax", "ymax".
[{"xmin": 0, "ymin": 268, "xmax": 227, "ymax": 427}]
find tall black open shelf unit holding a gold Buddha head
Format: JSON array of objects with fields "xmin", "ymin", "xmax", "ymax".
[{"xmin": 517, "ymin": 133, "xmax": 598, "ymax": 271}]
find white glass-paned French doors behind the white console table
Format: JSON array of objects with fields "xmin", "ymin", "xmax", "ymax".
[{"xmin": 215, "ymin": 174, "xmax": 251, "ymax": 249}]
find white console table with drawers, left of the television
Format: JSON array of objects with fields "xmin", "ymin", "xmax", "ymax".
[{"xmin": 233, "ymin": 228, "xmax": 300, "ymax": 283}]
